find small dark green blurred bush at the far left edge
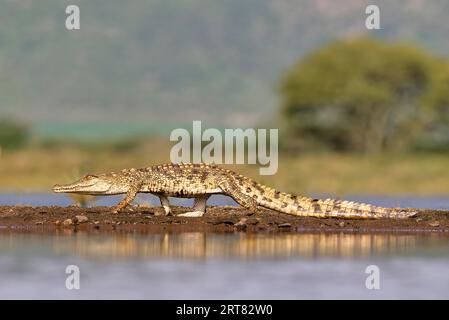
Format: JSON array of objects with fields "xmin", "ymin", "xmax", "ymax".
[{"xmin": 0, "ymin": 119, "xmax": 29, "ymax": 151}]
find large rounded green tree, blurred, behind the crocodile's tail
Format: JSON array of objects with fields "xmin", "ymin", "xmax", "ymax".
[{"xmin": 280, "ymin": 38, "xmax": 449, "ymax": 152}]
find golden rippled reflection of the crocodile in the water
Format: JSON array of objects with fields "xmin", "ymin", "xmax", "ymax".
[{"xmin": 45, "ymin": 232, "xmax": 439, "ymax": 259}]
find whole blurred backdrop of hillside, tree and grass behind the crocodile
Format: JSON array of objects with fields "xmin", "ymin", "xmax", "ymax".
[{"xmin": 0, "ymin": 0, "xmax": 449, "ymax": 196}]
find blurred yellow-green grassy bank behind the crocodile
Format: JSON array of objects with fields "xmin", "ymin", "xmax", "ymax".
[{"xmin": 0, "ymin": 139, "xmax": 449, "ymax": 196}]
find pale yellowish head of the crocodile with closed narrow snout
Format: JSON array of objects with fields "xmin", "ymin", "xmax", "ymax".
[{"xmin": 53, "ymin": 174, "xmax": 129, "ymax": 195}]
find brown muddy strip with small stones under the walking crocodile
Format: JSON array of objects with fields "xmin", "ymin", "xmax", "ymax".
[{"xmin": 0, "ymin": 206, "xmax": 449, "ymax": 233}]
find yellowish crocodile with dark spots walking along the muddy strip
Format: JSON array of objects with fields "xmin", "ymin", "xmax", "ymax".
[{"xmin": 53, "ymin": 164, "xmax": 417, "ymax": 219}]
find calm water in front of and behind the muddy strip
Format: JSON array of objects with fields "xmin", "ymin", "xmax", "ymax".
[{"xmin": 0, "ymin": 195, "xmax": 449, "ymax": 299}]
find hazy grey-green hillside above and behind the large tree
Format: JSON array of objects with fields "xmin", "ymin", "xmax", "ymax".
[{"xmin": 0, "ymin": 0, "xmax": 449, "ymax": 132}]
